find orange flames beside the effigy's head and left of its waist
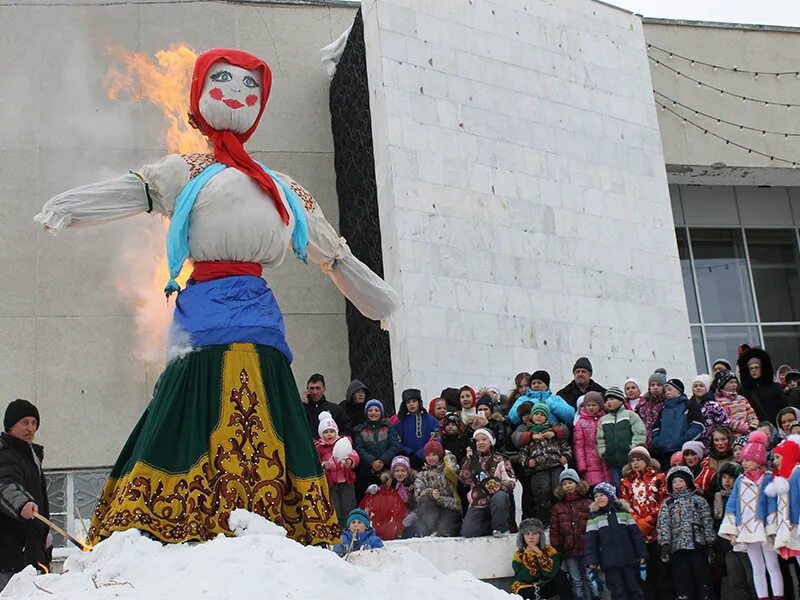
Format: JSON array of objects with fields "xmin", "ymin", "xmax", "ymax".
[{"xmin": 103, "ymin": 44, "xmax": 209, "ymax": 363}]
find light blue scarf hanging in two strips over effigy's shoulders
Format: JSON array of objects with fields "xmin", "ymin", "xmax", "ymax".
[{"xmin": 164, "ymin": 163, "xmax": 308, "ymax": 296}]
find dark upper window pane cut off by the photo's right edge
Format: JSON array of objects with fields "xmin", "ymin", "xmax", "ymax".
[{"xmin": 745, "ymin": 229, "xmax": 800, "ymax": 322}]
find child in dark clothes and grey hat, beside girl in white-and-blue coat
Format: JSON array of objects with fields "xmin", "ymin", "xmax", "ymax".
[{"xmin": 713, "ymin": 462, "xmax": 756, "ymax": 600}]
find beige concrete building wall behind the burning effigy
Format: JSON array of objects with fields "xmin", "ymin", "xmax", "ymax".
[{"xmin": 0, "ymin": 2, "xmax": 355, "ymax": 467}]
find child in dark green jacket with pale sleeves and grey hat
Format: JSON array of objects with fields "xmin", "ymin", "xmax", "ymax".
[{"xmin": 596, "ymin": 387, "xmax": 647, "ymax": 486}]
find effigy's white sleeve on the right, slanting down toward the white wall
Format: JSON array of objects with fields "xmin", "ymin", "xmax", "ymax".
[{"xmin": 281, "ymin": 174, "xmax": 398, "ymax": 329}]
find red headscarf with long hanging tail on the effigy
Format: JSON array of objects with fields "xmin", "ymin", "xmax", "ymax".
[{"xmin": 189, "ymin": 48, "xmax": 289, "ymax": 224}]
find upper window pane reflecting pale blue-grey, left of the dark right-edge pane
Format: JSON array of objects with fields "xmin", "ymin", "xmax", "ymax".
[{"xmin": 689, "ymin": 228, "xmax": 756, "ymax": 324}]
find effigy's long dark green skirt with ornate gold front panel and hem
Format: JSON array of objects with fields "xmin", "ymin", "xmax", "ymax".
[{"xmin": 89, "ymin": 344, "xmax": 340, "ymax": 544}]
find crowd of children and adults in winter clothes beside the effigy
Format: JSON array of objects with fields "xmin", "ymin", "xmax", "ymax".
[{"xmin": 306, "ymin": 346, "xmax": 800, "ymax": 600}]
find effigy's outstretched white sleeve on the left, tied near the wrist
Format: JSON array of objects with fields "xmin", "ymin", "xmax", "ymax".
[{"xmin": 33, "ymin": 154, "xmax": 189, "ymax": 230}]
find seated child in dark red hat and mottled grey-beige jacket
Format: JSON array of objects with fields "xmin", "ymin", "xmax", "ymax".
[{"xmin": 403, "ymin": 440, "xmax": 461, "ymax": 537}]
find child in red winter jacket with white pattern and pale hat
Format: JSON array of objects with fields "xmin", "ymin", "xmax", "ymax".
[{"xmin": 619, "ymin": 446, "xmax": 672, "ymax": 598}]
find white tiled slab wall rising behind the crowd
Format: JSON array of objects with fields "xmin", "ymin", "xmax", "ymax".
[{"xmin": 362, "ymin": 0, "xmax": 694, "ymax": 404}]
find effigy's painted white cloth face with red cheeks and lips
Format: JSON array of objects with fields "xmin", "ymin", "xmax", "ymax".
[{"xmin": 199, "ymin": 60, "xmax": 262, "ymax": 133}]
